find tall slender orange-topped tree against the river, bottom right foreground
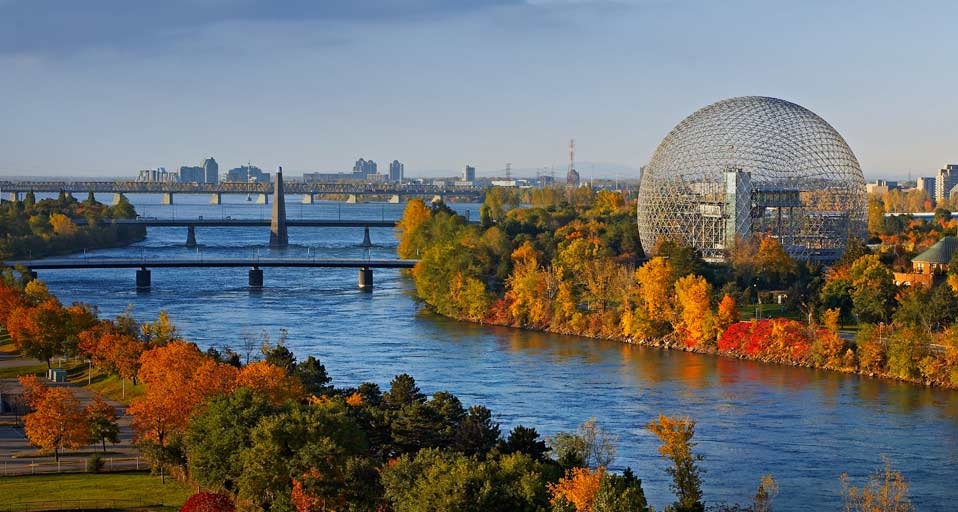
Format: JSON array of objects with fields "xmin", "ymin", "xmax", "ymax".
[{"xmin": 645, "ymin": 415, "xmax": 705, "ymax": 512}]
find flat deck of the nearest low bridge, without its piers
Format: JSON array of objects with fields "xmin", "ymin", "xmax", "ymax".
[{"xmin": 3, "ymin": 257, "xmax": 419, "ymax": 270}]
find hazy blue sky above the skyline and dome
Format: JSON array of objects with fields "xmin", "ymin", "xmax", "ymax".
[{"xmin": 0, "ymin": 0, "xmax": 958, "ymax": 179}]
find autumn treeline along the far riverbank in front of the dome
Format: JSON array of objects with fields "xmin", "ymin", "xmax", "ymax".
[{"xmin": 398, "ymin": 188, "xmax": 958, "ymax": 387}]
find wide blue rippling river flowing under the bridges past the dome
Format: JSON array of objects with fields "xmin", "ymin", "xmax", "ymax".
[{"xmin": 40, "ymin": 194, "xmax": 958, "ymax": 511}]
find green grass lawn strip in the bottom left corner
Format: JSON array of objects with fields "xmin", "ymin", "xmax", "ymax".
[{"xmin": 0, "ymin": 473, "xmax": 193, "ymax": 510}]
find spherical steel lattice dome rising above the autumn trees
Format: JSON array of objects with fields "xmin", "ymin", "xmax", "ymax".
[{"xmin": 638, "ymin": 96, "xmax": 867, "ymax": 262}]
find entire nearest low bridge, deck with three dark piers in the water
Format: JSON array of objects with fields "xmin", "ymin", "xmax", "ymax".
[{"xmin": 3, "ymin": 257, "xmax": 418, "ymax": 291}]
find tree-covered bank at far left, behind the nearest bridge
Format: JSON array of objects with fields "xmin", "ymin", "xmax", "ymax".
[{"xmin": 0, "ymin": 192, "xmax": 146, "ymax": 261}]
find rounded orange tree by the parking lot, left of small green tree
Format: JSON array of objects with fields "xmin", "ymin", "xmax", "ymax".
[{"xmin": 23, "ymin": 387, "xmax": 90, "ymax": 462}]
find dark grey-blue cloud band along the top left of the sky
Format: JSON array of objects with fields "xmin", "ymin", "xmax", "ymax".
[{"xmin": 0, "ymin": 0, "xmax": 524, "ymax": 55}]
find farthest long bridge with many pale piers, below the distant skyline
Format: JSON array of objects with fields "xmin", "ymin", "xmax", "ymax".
[{"xmin": 0, "ymin": 180, "xmax": 485, "ymax": 204}]
